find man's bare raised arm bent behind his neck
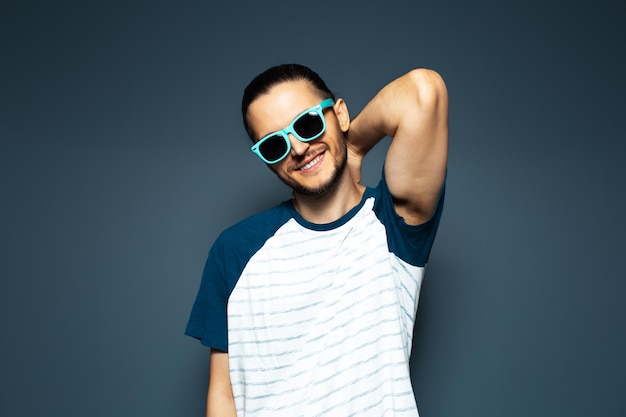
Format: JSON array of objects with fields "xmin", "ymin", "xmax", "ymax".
[{"xmin": 347, "ymin": 69, "xmax": 448, "ymax": 224}]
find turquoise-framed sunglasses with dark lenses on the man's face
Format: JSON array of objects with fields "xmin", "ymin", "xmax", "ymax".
[{"xmin": 250, "ymin": 98, "xmax": 334, "ymax": 164}]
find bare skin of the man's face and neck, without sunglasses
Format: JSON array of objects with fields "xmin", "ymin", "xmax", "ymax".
[{"xmin": 248, "ymin": 81, "xmax": 364, "ymax": 223}]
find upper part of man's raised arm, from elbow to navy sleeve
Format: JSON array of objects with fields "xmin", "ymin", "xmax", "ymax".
[{"xmin": 385, "ymin": 69, "xmax": 448, "ymax": 224}]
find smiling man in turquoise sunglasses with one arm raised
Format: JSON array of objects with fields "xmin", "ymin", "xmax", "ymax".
[{"xmin": 186, "ymin": 65, "xmax": 448, "ymax": 417}]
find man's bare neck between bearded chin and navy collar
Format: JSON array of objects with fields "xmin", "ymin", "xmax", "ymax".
[{"xmin": 293, "ymin": 171, "xmax": 365, "ymax": 224}]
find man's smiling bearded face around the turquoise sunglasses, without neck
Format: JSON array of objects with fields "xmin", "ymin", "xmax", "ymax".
[{"xmin": 248, "ymin": 81, "xmax": 347, "ymax": 196}]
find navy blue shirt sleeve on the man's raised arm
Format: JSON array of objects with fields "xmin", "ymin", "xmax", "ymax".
[{"xmin": 374, "ymin": 170, "xmax": 445, "ymax": 266}]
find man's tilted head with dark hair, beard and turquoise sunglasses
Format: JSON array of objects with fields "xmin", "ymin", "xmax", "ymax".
[{"xmin": 241, "ymin": 64, "xmax": 349, "ymax": 196}]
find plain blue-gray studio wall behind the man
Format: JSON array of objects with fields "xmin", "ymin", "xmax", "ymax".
[{"xmin": 0, "ymin": 0, "xmax": 626, "ymax": 417}]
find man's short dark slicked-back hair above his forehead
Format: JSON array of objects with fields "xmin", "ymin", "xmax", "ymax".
[{"xmin": 241, "ymin": 64, "xmax": 335, "ymax": 141}]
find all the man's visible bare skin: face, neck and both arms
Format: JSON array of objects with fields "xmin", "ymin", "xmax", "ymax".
[{"xmin": 207, "ymin": 69, "xmax": 448, "ymax": 417}]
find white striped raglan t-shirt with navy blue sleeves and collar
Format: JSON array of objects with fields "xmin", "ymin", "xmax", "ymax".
[{"xmin": 186, "ymin": 178, "xmax": 443, "ymax": 417}]
